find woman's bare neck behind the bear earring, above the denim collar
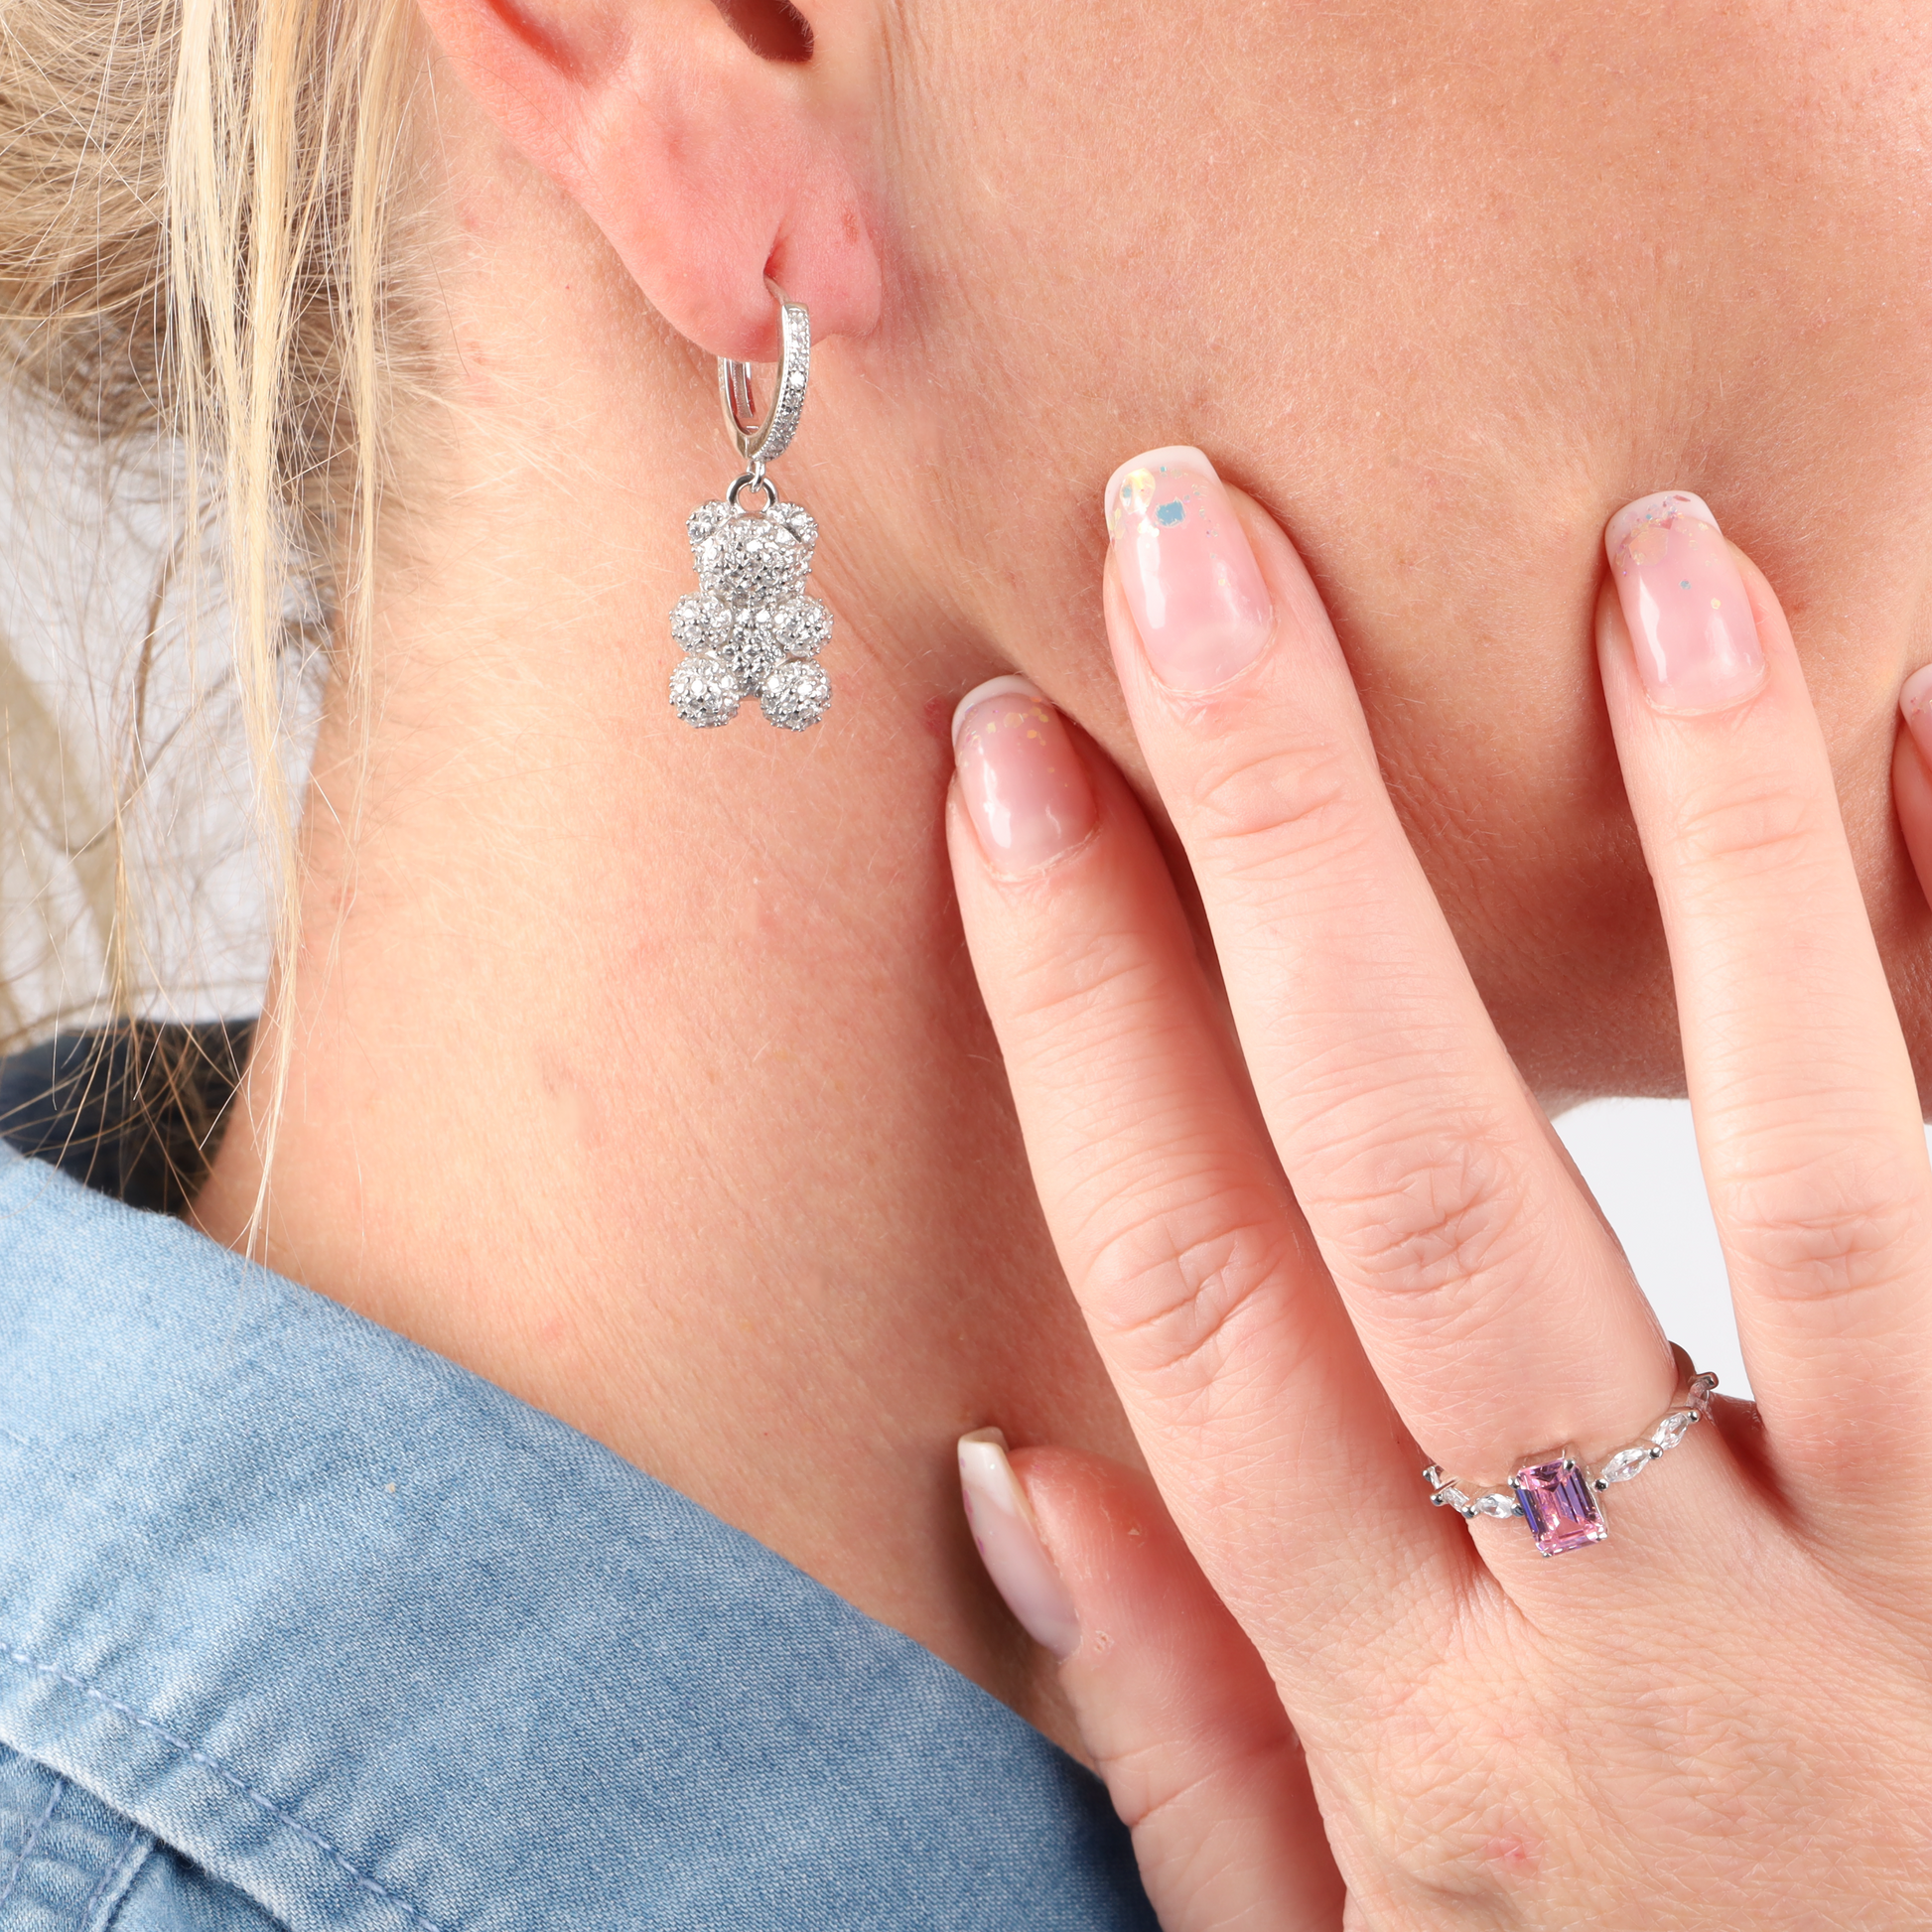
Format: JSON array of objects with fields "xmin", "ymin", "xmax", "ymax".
[{"xmin": 197, "ymin": 128, "xmax": 1132, "ymax": 1731}]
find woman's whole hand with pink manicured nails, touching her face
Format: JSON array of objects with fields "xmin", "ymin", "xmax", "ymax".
[{"xmin": 948, "ymin": 464, "xmax": 1932, "ymax": 1932}]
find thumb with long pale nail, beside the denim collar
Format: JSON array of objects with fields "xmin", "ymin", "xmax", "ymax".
[{"xmin": 960, "ymin": 1430, "xmax": 1342, "ymax": 1932}]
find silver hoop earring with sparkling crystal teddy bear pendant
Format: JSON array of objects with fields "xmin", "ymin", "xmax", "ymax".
[{"xmin": 670, "ymin": 280, "xmax": 833, "ymax": 731}]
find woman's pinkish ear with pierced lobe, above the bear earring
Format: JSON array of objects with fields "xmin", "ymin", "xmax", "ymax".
[{"xmin": 419, "ymin": 0, "xmax": 879, "ymax": 361}]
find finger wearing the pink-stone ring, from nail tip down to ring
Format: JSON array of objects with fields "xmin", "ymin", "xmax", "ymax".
[{"xmin": 1107, "ymin": 450, "xmax": 1675, "ymax": 1491}]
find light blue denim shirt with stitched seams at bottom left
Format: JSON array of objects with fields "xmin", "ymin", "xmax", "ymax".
[{"xmin": 0, "ymin": 1154, "xmax": 1154, "ymax": 1932}]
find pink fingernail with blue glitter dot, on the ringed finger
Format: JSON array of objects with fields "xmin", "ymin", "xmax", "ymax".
[{"xmin": 1107, "ymin": 447, "xmax": 1275, "ymax": 692}]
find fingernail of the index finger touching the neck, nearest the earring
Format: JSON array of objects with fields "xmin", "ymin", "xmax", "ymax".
[{"xmin": 952, "ymin": 678, "xmax": 1097, "ymax": 876}]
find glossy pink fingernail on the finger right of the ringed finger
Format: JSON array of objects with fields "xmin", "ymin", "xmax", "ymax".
[{"xmin": 1603, "ymin": 488, "xmax": 1764, "ymax": 711}]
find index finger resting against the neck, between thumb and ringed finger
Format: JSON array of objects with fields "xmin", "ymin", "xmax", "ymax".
[{"xmin": 947, "ymin": 678, "xmax": 1468, "ymax": 1627}]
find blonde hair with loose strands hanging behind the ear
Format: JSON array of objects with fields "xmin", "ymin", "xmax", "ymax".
[{"xmin": 0, "ymin": 0, "xmax": 421, "ymax": 1205}]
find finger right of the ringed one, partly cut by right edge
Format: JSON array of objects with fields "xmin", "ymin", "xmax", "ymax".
[{"xmin": 1597, "ymin": 492, "xmax": 1932, "ymax": 1513}]
